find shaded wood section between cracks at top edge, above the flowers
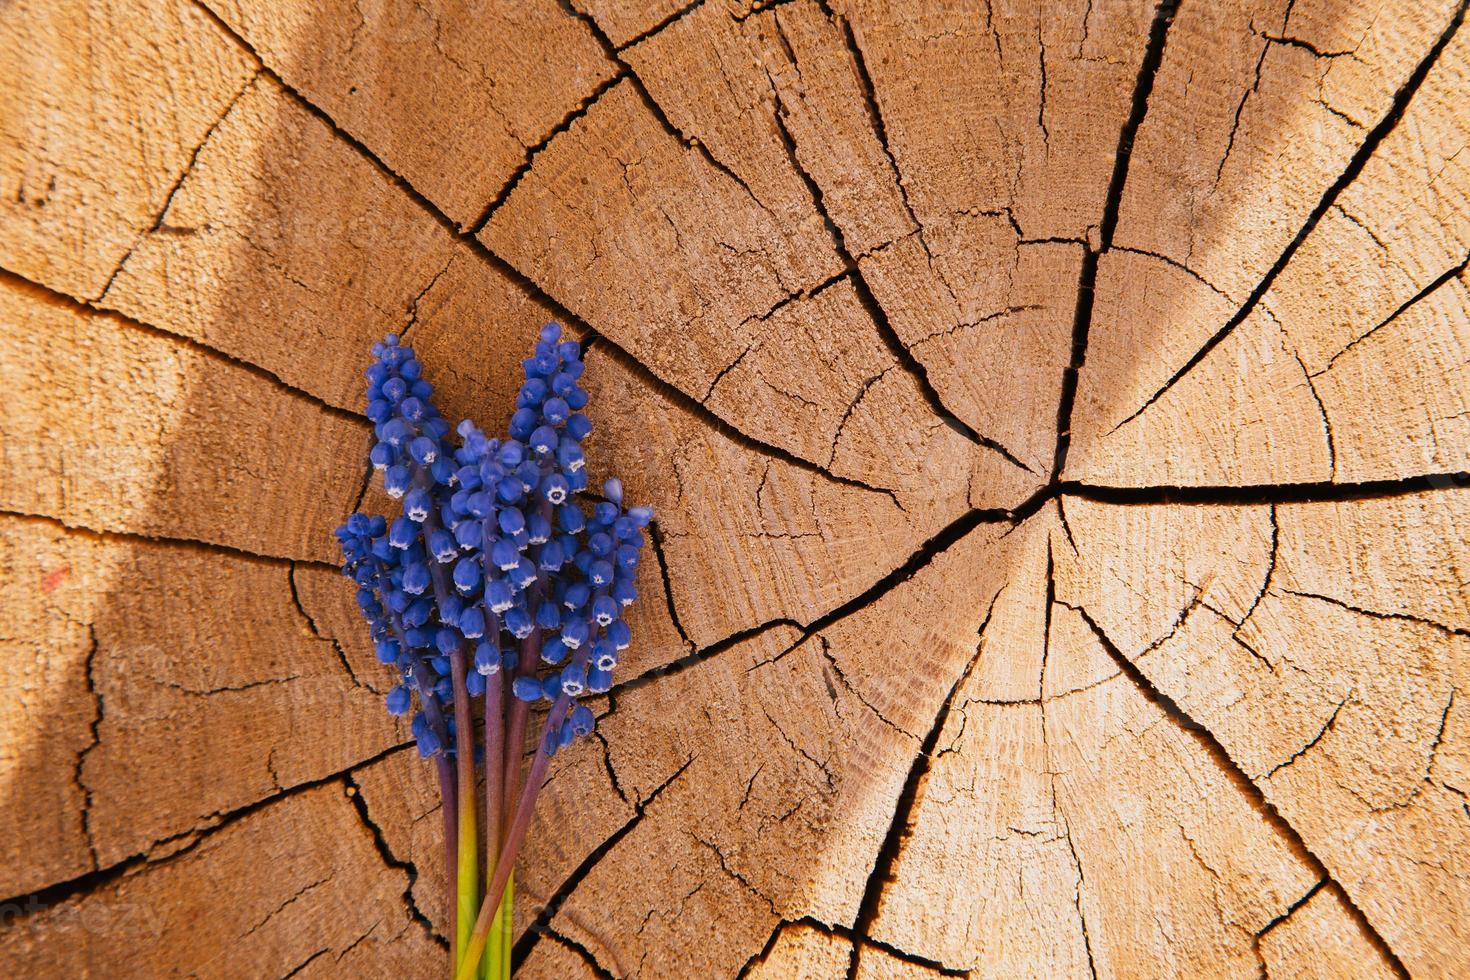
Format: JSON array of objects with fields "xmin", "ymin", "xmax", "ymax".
[{"xmin": 204, "ymin": 0, "xmax": 616, "ymax": 228}]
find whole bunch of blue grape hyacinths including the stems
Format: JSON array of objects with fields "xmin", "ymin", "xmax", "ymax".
[{"xmin": 337, "ymin": 323, "xmax": 653, "ymax": 980}]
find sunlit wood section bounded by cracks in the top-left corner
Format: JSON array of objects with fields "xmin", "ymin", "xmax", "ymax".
[{"xmin": 0, "ymin": 0, "xmax": 256, "ymax": 298}]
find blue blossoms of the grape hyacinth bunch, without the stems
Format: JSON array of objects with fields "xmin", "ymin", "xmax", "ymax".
[{"xmin": 337, "ymin": 323, "xmax": 653, "ymax": 757}]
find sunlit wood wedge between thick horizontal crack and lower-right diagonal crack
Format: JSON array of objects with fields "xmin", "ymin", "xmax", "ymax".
[{"xmin": 1058, "ymin": 491, "xmax": 1470, "ymax": 973}]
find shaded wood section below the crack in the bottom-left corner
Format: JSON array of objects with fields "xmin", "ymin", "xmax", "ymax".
[{"xmin": 0, "ymin": 783, "xmax": 438, "ymax": 977}]
